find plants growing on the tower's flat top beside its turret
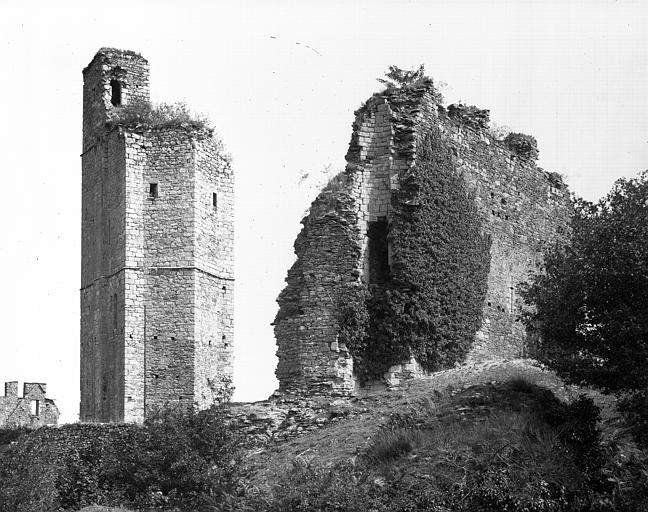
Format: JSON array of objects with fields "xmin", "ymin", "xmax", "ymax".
[{"xmin": 109, "ymin": 100, "xmax": 213, "ymax": 131}]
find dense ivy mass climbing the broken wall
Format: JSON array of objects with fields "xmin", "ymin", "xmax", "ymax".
[{"xmin": 339, "ymin": 125, "xmax": 490, "ymax": 379}]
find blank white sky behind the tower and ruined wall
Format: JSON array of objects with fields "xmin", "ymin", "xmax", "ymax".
[{"xmin": 0, "ymin": 0, "xmax": 648, "ymax": 422}]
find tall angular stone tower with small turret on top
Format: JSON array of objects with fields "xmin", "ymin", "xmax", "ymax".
[{"xmin": 80, "ymin": 48, "xmax": 234, "ymax": 422}]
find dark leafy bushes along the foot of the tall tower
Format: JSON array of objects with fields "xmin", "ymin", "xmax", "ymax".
[{"xmin": 0, "ymin": 407, "xmax": 239, "ymax": 512}]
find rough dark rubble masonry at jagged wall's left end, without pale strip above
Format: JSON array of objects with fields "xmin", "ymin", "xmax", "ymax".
[{"xmin": 275, "ymin": 188, "xmax": 361, "ymax": 394}]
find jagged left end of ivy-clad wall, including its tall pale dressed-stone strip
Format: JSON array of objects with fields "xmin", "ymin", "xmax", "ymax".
[{"xmin": 275, "ymin": 90, "xmax": 426, "ymax": 394}]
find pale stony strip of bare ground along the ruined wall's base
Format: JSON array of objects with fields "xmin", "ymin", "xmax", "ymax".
[{"xmin": 240, "ymin": 359, "xmax": 621, "ymax": 487}]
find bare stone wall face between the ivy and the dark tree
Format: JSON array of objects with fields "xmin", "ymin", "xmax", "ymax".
[{"xmin": 440, "ymin": 113, "xmax": 570, "ymax": 360}]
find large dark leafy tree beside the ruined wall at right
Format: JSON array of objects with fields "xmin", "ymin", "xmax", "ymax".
[{"xmin": 522, "ymin": 171, "xmax": 648, "ymax": 391}]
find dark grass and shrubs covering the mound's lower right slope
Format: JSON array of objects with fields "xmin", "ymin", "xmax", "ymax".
[{"xmin": 267, "ymin": 380, "xmax": 648, "ymax": 512}]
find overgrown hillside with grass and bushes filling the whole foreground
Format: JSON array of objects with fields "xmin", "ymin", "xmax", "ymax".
[{"xmin": 0, "ymin": 362, "xmax": 648, "ymax": 512}]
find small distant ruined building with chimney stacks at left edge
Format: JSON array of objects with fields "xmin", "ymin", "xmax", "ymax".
[{"xmin": 0, "ymin": 381, "xmax": 59, "ymax": 428}]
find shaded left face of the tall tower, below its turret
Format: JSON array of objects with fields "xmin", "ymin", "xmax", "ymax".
[{"xmin": 81, "ymin": 132, "xmax": 125, "ymax": 421}]
